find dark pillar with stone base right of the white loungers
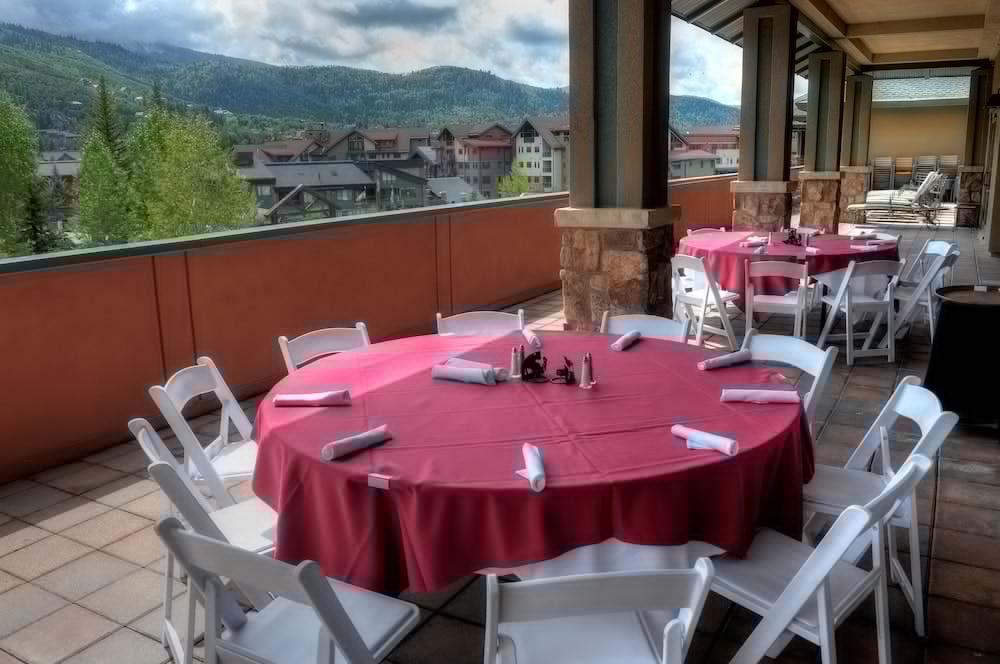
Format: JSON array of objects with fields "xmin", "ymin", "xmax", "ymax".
[{"xmin": 955, "ymin": 68, "xmax": 993, "ymax": 227}]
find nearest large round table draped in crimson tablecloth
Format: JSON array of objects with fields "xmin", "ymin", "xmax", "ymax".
[{"xmin": 254, "ymin": 333, "xmax": 813, "ymax": 592}]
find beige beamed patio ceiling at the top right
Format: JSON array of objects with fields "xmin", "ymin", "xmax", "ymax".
[{"xmin": 672, "ymin": 0, "xmax": 1000, "ymax": 76}]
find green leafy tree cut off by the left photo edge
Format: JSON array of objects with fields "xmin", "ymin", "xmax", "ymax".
[{"xmin": 0, "ymin": 90, "xmax": 38, "ymax": 255}]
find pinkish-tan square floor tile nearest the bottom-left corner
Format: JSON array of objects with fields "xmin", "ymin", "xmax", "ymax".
[{"xmin": 0, "ymin": 604, "xmax": 118, "ymax": 664}]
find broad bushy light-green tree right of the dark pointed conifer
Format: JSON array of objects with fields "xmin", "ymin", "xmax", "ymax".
[{"xmin": 129, "ymin": 112, "xmax": 256, "ymax": 239}]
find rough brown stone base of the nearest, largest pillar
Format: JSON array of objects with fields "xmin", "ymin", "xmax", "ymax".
[{"xmin": 556, "ymin": 206, "xmax": 680, "ymax": 331}]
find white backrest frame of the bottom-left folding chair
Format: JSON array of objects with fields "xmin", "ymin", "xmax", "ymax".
[{"xmin": 156, "ymin": 519, "xmax": 375, "ymax": 664}]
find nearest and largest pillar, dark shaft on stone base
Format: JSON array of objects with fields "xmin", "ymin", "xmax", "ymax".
[{"xmin": 556, "ymin": 0, "xmax": 674, "ymax": 329}]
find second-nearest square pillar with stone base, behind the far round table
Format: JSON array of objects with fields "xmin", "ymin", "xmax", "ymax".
[{"xmin": 732, "ymin": 5, "xmax": 798, "ymax": 230}]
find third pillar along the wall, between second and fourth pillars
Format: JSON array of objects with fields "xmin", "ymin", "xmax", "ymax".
[{"xmin": 799, "ymin": 51, "xmax": 846, "ymax": 233}]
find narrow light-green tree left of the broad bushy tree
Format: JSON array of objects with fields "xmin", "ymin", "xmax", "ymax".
[{"xmin": 80, "ymin": 130, "xmax": 138, "ymax": 244}]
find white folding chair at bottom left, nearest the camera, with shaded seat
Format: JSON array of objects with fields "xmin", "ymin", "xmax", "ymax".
[{"xmin": 156, "ymin": 519, "xmax": 420, "ymax": 664}]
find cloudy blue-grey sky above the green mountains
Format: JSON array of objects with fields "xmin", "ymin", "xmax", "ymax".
[{"xmin": 0, "ymin": 0, "xmax": 808, "ymax": 104}]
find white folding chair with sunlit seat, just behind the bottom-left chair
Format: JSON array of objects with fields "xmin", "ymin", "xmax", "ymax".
[{"xmin": 149, "ymin": 461, "xmax": 278, "ymax": 664}]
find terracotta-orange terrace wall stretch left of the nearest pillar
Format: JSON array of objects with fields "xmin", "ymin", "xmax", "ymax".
[{"xmin": 0, "ymin": 196, "xmax": 567, "ymax": 482}]
